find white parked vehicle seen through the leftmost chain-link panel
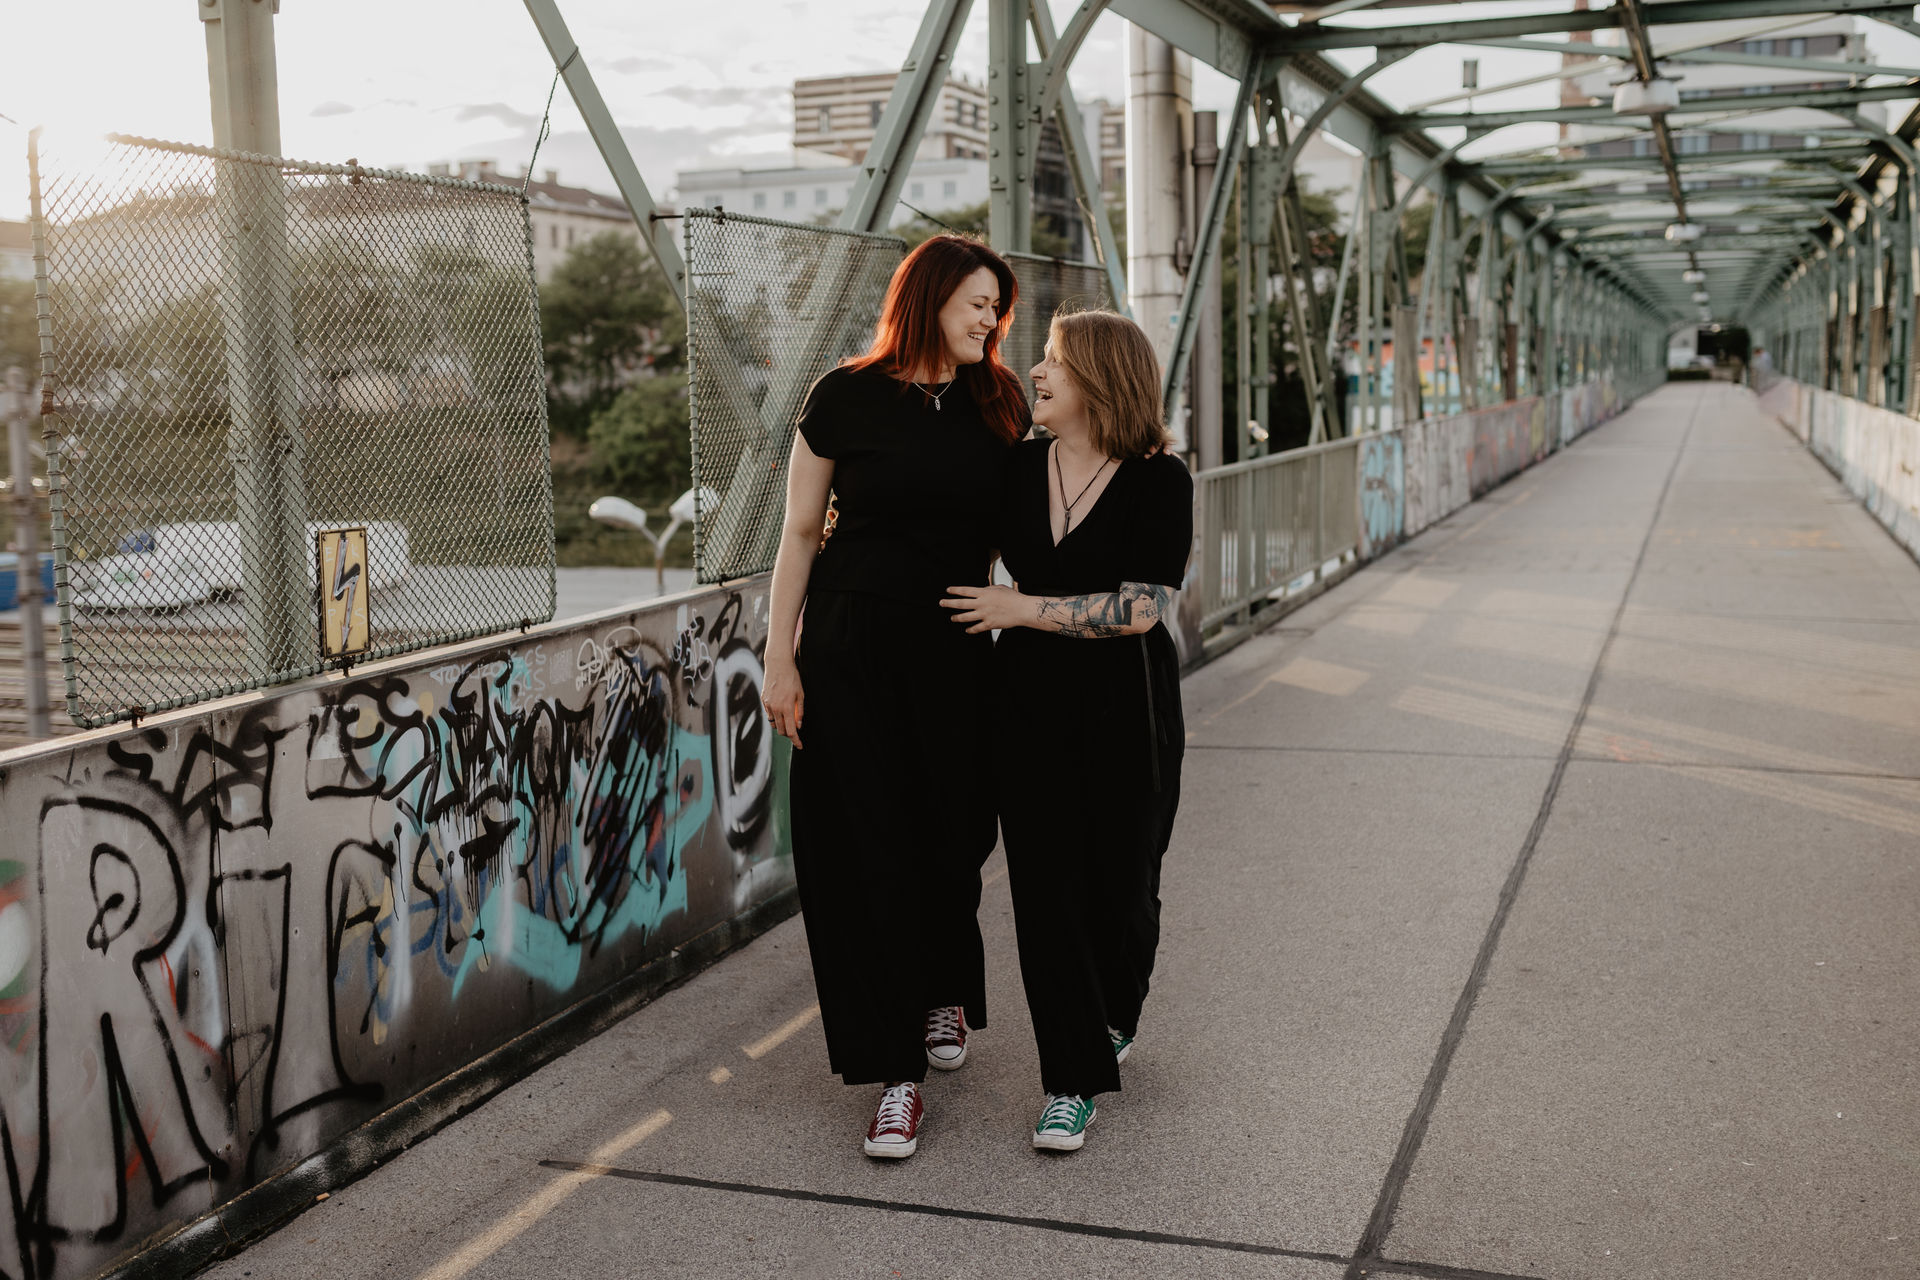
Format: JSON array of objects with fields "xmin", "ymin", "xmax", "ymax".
[{"xmin": 67, "ymin": 520, "xmax": 413, "ymax": 614}]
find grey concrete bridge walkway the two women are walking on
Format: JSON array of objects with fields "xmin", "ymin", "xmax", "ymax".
[{"xmin": 211, "ymin": 384, "xmax": 1920, "ymax": 1280}]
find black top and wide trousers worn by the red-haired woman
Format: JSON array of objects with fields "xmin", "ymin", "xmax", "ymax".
[{"xmin": 791, "ymin": 368, "xmax": 1010, "ymax": 1084}]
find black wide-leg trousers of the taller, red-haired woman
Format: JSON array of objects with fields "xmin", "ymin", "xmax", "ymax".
[{"xmin": 789, "ymin": 591, "xmax": 995, "ymax": 1084}]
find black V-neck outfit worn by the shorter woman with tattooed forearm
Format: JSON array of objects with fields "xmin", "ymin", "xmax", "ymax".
[{"xmin": 995, "ymin": 439, "xmax": 1192, "ymax": 1098}]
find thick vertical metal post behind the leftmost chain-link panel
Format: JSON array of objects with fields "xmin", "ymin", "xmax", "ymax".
[{"xmin": 200, "ymin": 0, "xmax": 313, "ymax": 681}]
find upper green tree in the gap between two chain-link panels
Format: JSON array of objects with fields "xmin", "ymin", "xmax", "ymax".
[{"xmin": 540, "ymin": 230, "xmax": 687, "ymax": 430}]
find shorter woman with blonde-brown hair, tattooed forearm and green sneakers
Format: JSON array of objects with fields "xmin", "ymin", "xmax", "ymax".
[{"xmin": 943, "ymin": 311, "xmax": 1192, "ymax": 1151}]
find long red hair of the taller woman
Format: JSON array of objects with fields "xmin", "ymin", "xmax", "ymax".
[{"xmin": 847, "ymin": 236, "xmax": 1031, "ymax": 443}]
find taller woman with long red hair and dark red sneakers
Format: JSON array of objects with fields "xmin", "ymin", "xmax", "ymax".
[{"xmin": 764, "ymin": 236, "xmax": 1029, "ymax": 1159}]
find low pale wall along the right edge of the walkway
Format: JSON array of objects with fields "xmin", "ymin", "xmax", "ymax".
[{"xmin": 1761, "ymin": 378, "xmax": 1920, "ymax": 557}]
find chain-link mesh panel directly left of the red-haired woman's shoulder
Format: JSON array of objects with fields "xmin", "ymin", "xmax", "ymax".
[{"xmin": 684, "ymin": 209, "xmax": 906, "ymax": 581}]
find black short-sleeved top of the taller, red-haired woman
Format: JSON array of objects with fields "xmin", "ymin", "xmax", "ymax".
[{"xmin": 801, "ymin": 368, "xmax": 1010, "ymax": 606}]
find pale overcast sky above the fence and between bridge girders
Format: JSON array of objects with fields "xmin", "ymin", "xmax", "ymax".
[{"xmin": 11, "ymin": 0, "xmax": 1920, "ymax": 217}]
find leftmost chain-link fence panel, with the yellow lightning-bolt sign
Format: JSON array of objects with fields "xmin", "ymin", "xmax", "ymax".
[{"xmin": 31, "ymin": 136, "xmax": 553, "ymax": 723}]
